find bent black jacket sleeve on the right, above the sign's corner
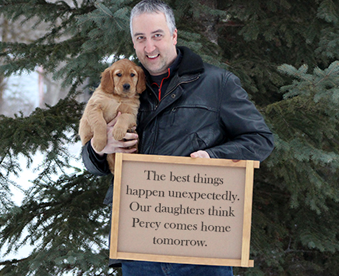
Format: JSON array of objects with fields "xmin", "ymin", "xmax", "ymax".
[{"xmin": 207, "ymin": 72, "xmax": 274, "ymax": 161}]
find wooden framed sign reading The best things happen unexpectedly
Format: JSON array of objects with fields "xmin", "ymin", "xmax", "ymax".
[{"xmin": 110, "ymin": 153, "xmax": 259, "ymax": 267}]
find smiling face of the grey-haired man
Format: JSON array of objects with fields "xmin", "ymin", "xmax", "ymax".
[{"xmin": 132, "ymin": 13, "xmax": 177, "ymax": 76}]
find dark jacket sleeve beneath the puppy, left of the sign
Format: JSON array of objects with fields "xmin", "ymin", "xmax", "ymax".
[{"xmin": 81, "ymin": 141, "xmax": 110, "ymax": 176}]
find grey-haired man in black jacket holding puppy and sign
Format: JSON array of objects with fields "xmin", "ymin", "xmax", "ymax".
[{"xmin": 83, "ymin": 0, "xmax": 273, "ymax": 276}]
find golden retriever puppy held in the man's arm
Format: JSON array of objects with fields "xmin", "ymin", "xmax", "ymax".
[{"xmin": 79, "ymin": 59, "xmax": 146, "ymax": 173}]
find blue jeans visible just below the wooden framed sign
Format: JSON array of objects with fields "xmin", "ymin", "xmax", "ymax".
[{"xmin": 122, "ymin": 261, "xmax": 233, "ymax": 276}]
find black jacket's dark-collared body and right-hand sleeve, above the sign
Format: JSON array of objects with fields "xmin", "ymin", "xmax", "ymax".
[{"xmin": 137, "ymin": 47, "xmax": 273, "ymax": 161}]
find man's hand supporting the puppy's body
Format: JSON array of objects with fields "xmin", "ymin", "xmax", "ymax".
[{"xmin": 91, "ymin": 112, "xmax": 138, "ymax": 156}]
